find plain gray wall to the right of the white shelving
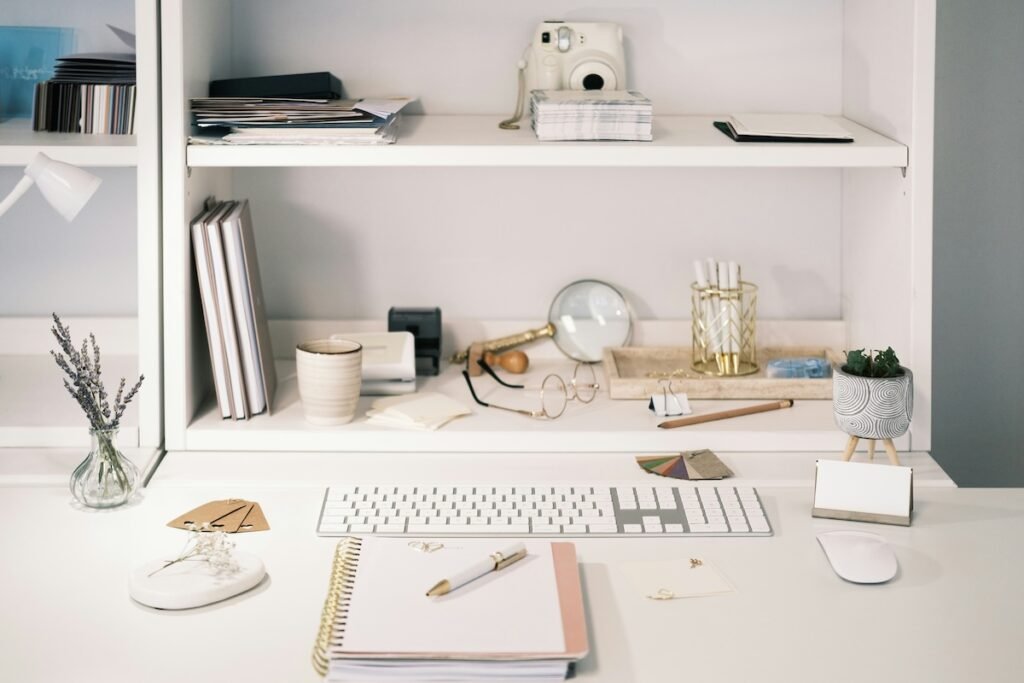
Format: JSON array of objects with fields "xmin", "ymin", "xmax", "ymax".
[{"xmin": 932, "ymin": 0, "xmax": 1024, "ymax": 486}]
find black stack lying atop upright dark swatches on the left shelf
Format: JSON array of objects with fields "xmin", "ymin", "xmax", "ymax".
[{"xmin": 32, "ymin": 52, "xmax": 135, "ymax": 135}]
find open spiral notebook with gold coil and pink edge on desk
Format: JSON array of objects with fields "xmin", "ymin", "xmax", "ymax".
[{"xmin": 313, "ymin": 537, "xmax": 588, "ymax": 682}]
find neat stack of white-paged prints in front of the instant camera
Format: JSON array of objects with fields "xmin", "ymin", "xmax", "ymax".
[{"xmin": 529, "ymin": 90, "xmax": 651, "ymax": 141}]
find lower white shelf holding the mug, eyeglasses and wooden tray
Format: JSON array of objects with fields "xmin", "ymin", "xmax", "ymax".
[{"xmin": 185, "ymin": 360, "xmax": 907, "ymax": 453}]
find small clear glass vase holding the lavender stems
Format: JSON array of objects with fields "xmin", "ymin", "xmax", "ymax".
[{"xmin": 71, "ymin": 429, "xmax": 138, "ymax": 508}]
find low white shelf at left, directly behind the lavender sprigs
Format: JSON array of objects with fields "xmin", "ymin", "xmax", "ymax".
[{"xmin": 0, "ymin": 353, "xmax": 138, "ymax": 449}]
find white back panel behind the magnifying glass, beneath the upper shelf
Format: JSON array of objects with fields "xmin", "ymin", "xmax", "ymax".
[{"xmin": 233, "ymin": 168, "xmax": 841, "ymax": 321}]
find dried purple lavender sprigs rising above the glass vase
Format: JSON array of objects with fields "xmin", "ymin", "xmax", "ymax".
[{"xmin": 50, "ymin": 313, "xmax": 145, "ymax": 431}]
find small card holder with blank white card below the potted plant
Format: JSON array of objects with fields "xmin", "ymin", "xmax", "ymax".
[{"xmin": 811, "ymin": 460, "xmax": 913, "ymax": 526}]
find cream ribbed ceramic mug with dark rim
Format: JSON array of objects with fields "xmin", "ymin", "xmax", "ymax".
[{"xmin": 295, "ymin": 339, "xmax": 362, "ymax": 425}]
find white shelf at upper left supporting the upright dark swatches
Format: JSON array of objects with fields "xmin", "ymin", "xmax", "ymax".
[{"xmin": 0, "ymin": 119, "xmax": 138, "ymax": 167}]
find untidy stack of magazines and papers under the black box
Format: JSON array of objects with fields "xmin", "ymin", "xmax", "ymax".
[{"xmin": 190, "ymin": 97, "xmax": 412, "ymax": 144}]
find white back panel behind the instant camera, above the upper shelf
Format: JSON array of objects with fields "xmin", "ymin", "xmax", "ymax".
[{"xmin": 230, "ymin": 0, "xmax": 843, "ymax": 114}]
